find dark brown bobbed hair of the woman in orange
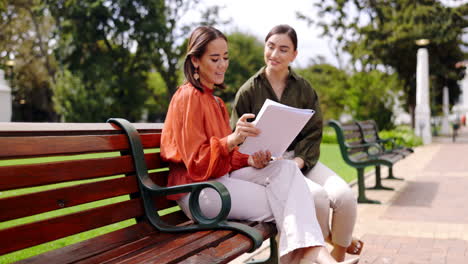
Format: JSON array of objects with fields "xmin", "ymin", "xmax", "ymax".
[{"xmin": 184, "ymin": 26, "xmax": 227, "ymax": 92}]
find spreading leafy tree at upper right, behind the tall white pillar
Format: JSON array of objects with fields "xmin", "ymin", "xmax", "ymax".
[{"xmin": 299, "ymin": 0, "xmax": 468, "ymax": 127}]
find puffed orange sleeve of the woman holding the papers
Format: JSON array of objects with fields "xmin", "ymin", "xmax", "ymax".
[{"xmin": 161, "ymin": 87, "xmax": 247, "ymax": 182}]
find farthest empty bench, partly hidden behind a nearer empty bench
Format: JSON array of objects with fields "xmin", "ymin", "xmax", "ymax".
[{"xmin": 356, "ymin": 120, "xmax": 414, "ymax": 180}]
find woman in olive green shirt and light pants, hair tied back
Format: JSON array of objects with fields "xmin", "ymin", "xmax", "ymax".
[{"xmin": 231, "ymin": 25, "xmax": 363, "ymax": 261}]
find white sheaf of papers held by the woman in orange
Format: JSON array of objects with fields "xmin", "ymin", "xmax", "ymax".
[{"xmin": 239, "ymin": 99, "xmax": 315, "ymax": 157}]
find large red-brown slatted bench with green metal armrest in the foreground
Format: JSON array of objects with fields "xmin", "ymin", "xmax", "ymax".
[{"xmin": 0, "ymin": 119, "xmax": 278, "ymax": 263}]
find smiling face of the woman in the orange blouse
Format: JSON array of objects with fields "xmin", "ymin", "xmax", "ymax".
[{"xmin": 192, "ymin": 38, "xmax": 229, "ymax": 89}]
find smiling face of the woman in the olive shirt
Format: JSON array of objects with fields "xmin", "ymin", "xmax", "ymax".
[{"xmin": 264, "ymin": 34, "xmax": 297, "ymax": 72}]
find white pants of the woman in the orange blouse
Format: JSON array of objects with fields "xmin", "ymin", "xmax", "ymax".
[{"xmin": 178, "ymin": 160, "xmax": 324, "ymax": 263}]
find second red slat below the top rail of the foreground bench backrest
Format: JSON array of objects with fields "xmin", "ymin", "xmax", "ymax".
[{"xmin": 0, "ymin": 153, "xmax": 166, "ymax": 191}]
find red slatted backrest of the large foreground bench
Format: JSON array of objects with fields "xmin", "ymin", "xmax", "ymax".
[{"xmin": 0, "ymin": 123, "xmax": 187, "ymax": 255}]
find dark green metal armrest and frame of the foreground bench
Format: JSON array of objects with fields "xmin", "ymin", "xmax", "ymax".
[{"xmin": 107, "ymin": 118, "xmax": 263, "ymax": 252}]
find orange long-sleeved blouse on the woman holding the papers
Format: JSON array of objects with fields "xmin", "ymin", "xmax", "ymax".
[{"xmin": 161, "ymin": 83, "xmax": 249, "ymax": 200}]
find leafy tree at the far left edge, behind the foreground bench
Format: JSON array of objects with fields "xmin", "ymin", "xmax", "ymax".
[{"xmin": 0, "ymin": 0, "xmax": 58, "ymax": 121}]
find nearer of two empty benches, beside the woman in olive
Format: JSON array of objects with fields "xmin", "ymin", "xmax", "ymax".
[{"xmin": 328, "ymin": 120, "xmax": 405, "ymax": 203}]
